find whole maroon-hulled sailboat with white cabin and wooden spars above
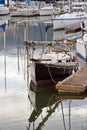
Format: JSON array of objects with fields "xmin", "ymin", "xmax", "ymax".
[{"xmin": 25, "ymin": 20, "xmax": 78, "ymax": 85}]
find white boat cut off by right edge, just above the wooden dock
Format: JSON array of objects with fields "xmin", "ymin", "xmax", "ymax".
[{"xmin": 76, "ymin": 33, "xmax": 87, "ymax": 60}]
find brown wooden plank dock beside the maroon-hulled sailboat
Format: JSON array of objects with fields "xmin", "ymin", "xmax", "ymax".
[{"xmin": 55, "ymin": 66, "xmax": 87, "ymax": 93}]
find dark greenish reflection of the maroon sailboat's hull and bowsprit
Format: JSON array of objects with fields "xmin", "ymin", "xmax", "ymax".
[{"xmin": 28, "ymin": 81, "xmax": 60, "ymax": 130}]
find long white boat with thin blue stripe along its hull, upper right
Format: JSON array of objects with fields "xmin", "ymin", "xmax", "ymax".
[{"xmin": 52, "ymin": 11, "xmax": 87, "ymax": 30}]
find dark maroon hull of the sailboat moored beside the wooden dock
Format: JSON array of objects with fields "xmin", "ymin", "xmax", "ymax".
[{"xmin": 30, "ymin": 62, "xmax": 77, "ymax": 85}]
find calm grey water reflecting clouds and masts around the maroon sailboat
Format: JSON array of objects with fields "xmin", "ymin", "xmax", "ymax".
[{"xmin": 0, "ymin": 15, "xmax": 87, "ymax": 130}]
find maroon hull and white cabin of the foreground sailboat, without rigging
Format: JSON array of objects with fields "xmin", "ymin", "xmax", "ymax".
[{"xmin": 28, "ymin": 40, "xmax": 78, "ymax": 85}]
